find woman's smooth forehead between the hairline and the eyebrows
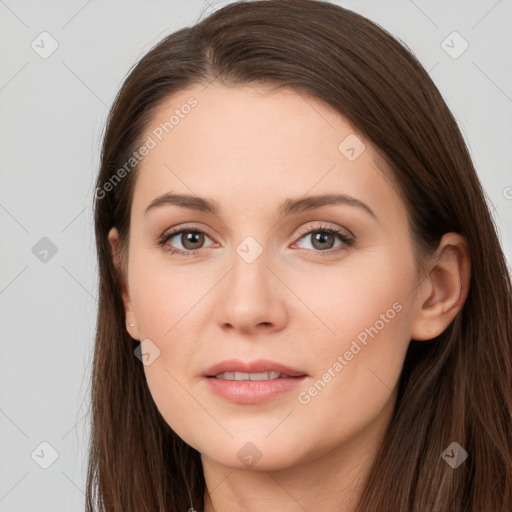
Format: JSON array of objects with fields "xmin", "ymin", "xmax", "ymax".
[{"xmin": 133, "ymin": 82, "xmax": 404, "ymax": 222}]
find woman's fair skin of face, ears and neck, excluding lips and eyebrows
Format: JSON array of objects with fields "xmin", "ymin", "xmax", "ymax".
[{"xmin": 109, "ymin": 83, "xmax": 470, "ymax": 512}]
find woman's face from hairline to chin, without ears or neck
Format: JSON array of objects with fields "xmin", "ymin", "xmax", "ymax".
[{"xmin": 111, "ymin": 83, "xmax": 426, "ymax": 470}]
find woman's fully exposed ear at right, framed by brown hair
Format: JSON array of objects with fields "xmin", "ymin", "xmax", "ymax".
[{"xmin": 411, "ymin": 233, "xmax": 471, "ymax": 340}]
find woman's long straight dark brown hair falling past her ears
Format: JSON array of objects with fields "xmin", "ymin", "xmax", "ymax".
[{"xmin": 87, "ymin": 0, "xmax": 512, "ymax": 512}]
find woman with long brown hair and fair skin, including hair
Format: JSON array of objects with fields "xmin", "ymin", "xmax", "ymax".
[{"xmin": 87, "ymin": 0, "xmax": 512, "ymax": 512}]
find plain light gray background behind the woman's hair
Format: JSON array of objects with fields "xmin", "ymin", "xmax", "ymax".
[{"xmin": 0, "ymin": 0, "xmax": 512, "ymax": 512}]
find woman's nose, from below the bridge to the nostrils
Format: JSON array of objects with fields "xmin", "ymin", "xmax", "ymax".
[{"xmin": 217, "ymin": 245, "xmax": 287, "ymax": 334}]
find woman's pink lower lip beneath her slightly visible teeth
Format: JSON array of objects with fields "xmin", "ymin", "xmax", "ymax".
[{"xmin": 205, "ymin": 375, "xmax": 306, "ymax": 404}]
